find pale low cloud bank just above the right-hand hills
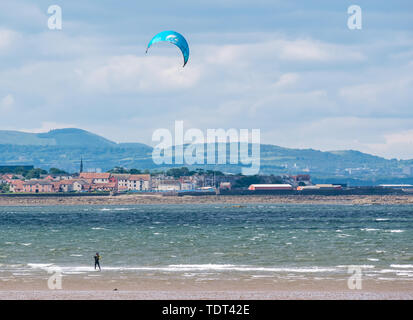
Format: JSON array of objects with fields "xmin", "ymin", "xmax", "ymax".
[{"xmin": 262, "ymin": 117, "xmax": 413, "ymax": 159}]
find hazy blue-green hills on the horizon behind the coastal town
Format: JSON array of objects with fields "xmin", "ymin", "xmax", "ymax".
[{"xmin": 0, "ymin": 128, "xmax": 413, "ymax": 184}]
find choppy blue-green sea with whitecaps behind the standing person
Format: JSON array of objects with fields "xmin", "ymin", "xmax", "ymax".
[{"xmin": 0, "ymin": 204, "xmax": 413, "ymax": 280}]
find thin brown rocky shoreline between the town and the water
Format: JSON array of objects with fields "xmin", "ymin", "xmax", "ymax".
[{"xmin": 0, "ymin": 194, "xmax": 413, "ymax": 206}]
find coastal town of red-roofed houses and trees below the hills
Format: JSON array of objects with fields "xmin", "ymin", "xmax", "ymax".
[{"xmin": 0, "ymin": 165, "xmax": 350, "ymax": 194}]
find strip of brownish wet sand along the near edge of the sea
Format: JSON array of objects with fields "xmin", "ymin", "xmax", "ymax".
[{"xmin": 0, "ymin": 281, "xmax": 413, "ymax": 300}]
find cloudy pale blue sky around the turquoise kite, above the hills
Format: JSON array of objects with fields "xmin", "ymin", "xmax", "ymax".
[{"xmin": 0, "ymin": 0, "xmax": 413, "ymax": 159}]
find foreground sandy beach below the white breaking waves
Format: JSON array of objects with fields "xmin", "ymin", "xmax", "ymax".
[{"xmin": 0, "ymin": 278, "xmax": 413, "ymax": 300}]
